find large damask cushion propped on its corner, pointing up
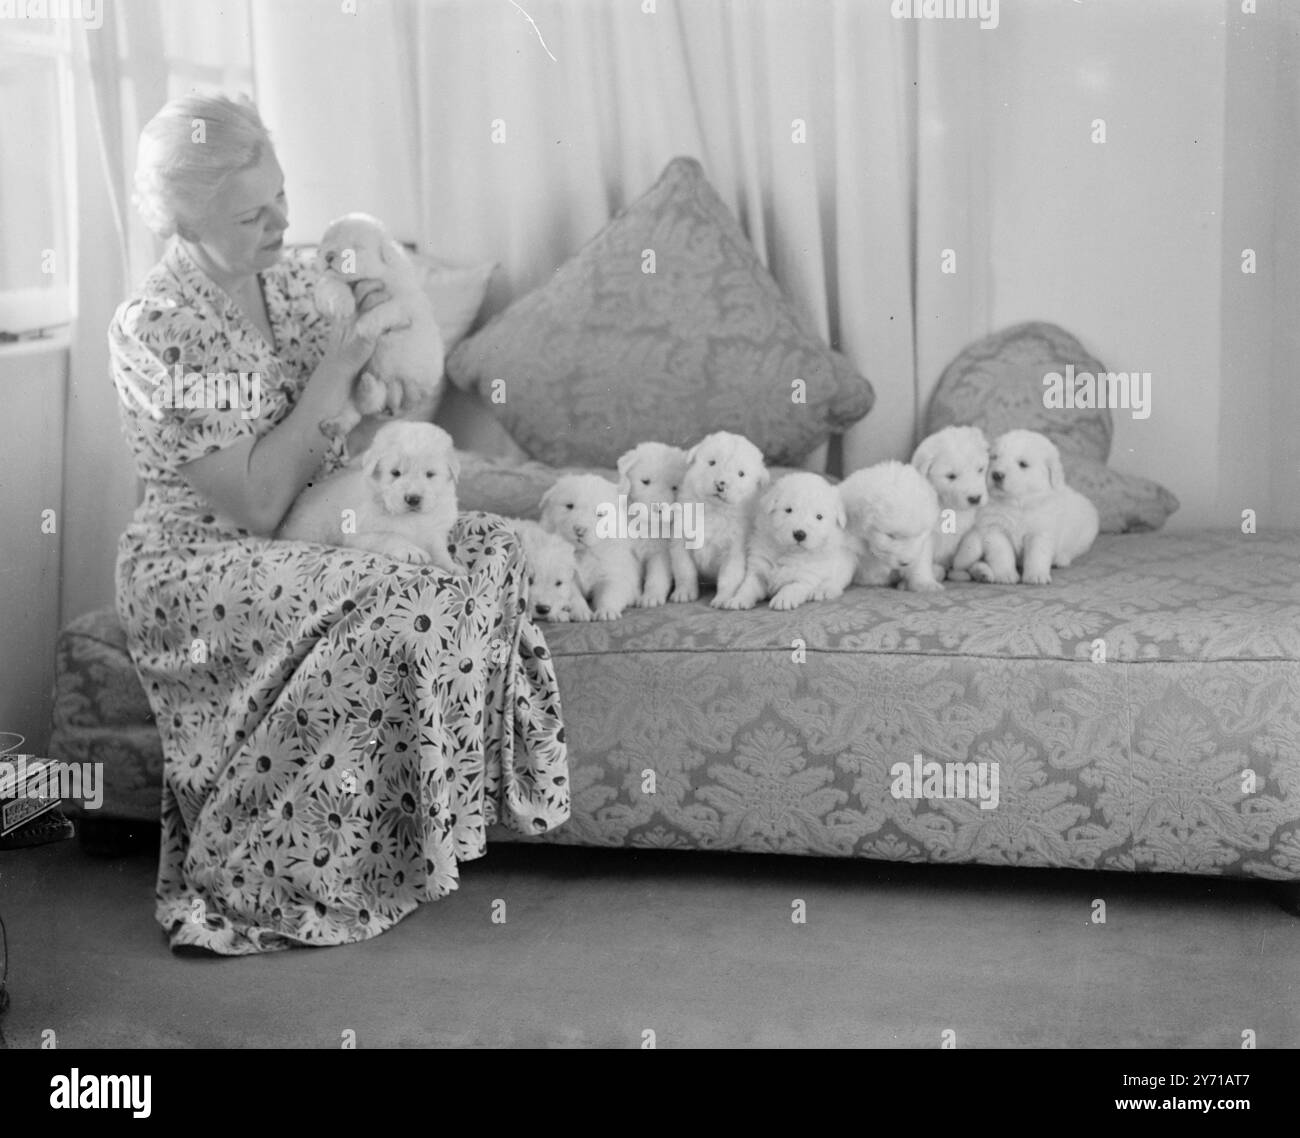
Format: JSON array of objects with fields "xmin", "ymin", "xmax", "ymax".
[{"xmin": 447, "ymin": 157, "xmax": 874, "ymax": 467}]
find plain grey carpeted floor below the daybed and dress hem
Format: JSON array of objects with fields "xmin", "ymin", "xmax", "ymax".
[{"xmin": 0, "ymin": 841, "xmax": 1300, "ymax": 1048}]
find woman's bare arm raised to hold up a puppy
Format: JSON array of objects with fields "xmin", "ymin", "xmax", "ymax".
[{"xmin": 178, "ymin": 282, "xmax": 395, "ymax": 537}]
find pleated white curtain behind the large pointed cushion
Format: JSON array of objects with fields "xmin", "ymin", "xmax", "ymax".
[{"xmin": 252, "ymin": 0, "xmax": 917, "ymax": 467}]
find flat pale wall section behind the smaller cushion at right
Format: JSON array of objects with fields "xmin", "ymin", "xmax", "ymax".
[{"xmin": 982, "ymin": 0, "xmax": 1226, "ymax": 527}]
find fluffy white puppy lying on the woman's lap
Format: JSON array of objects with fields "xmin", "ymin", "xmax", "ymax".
[{"xmin": 276, "ymin": 421, "xmax": 460, "ymax": 574}]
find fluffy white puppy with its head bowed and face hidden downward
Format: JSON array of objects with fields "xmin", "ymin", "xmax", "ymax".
[{"xmin": 839, "ymin": 462, "xmax": 943, "ymax": 592}]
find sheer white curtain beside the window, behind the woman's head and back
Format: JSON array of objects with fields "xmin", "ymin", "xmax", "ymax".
[{"xmin": 60, "ymin": 0, "xmax": 254, "ymax": 620}]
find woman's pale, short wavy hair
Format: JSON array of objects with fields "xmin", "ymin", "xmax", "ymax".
[{"xmin": 133, "ymin": 95, "xmax": 270, "ymax": 238}]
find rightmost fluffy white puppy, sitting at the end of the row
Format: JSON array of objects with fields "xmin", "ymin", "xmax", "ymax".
[{"xmin": 953, "ymin": 430, "xmax": 1100, "ymax": 585}]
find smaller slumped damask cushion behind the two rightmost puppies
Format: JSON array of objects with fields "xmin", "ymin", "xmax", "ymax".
[{"xmin": 923, "ymin": 323, "xmax": 1179, "ymax": 533}]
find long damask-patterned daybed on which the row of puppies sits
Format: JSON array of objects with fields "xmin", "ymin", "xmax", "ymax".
[{"xmin": 51, "ymin": 531, "xmax": 1300, "ymax": 880}]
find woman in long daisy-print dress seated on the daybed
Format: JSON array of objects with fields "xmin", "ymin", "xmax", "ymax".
[{"xmin": 109, "ymin": 98, "xmax": 568, "ymax": 955}]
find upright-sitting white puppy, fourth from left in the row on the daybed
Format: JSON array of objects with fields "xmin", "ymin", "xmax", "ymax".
[{"xmin": 672, "ymin": 430, "xmax": 772, "ymax": 609}]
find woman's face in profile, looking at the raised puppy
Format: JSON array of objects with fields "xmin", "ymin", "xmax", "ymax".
[{"xmin": 189, "ymin": 147, "xmax": 289, "ymax": 277}]
